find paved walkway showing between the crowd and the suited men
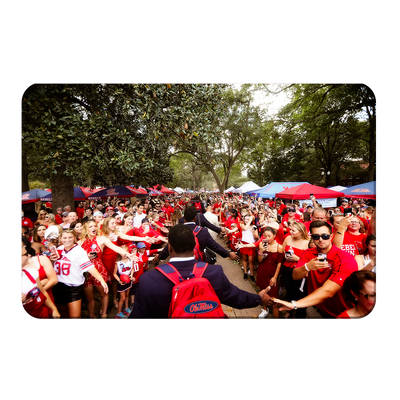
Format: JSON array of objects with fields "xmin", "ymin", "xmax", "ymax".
[{"xmin": 82, "ymin": 234, "xmax": 273, "ymax": 322}]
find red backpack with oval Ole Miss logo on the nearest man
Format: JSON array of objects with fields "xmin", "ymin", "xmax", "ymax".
[{"xmin": 156, "ymin": 262, "xmax": 228, "ymax": 322}]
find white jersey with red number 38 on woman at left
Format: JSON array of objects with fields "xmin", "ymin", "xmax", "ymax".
[{"xmin": 54, "ymin": 244, "xmax": 94, "ymax": 286}]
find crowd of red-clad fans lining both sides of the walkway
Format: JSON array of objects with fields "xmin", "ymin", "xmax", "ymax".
[{"xmin": 19, "ymin": 193, "xmax": 379, "ymax": 322}]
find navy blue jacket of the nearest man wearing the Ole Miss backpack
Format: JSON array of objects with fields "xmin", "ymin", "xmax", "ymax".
[{"xmin": 128, "ymin": 260, "xmax": 261, "ymax": 322}]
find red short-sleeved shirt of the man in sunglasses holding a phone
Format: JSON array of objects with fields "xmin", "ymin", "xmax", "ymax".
[{"xmin": 295, "ymin": 245, "xmax": 358, "ymax": 317}]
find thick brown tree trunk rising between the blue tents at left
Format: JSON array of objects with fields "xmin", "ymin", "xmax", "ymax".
[{"xmin": 50, "ymin": 165, "xmax": 75, "ymax": 212}]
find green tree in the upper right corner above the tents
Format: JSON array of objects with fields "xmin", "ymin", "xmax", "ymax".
[{"xmin": 279, "ymin": 83, "xmax": 379, "ymax": 183}]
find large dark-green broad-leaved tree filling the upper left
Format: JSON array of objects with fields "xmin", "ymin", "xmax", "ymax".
[{"xmin": 20, "ymin": 83, "xmax": 225, "ymax": 211}]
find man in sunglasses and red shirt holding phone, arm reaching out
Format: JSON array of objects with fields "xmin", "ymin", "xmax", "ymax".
[{"xmin": 274, "ymin": 221, "xmax": 358, "ymax": 322}]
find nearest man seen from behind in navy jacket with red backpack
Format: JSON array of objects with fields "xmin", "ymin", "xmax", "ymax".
[{"xmin": 128, "ymin": 224, "xmax": 273, "ymax": 322}]
